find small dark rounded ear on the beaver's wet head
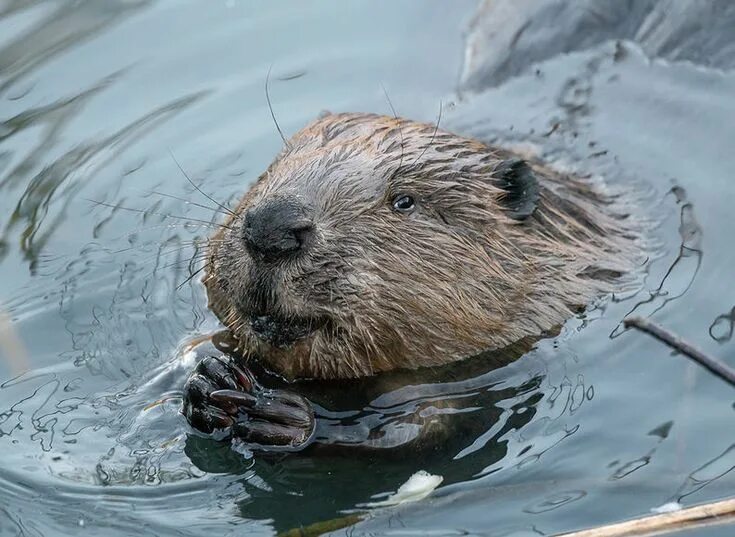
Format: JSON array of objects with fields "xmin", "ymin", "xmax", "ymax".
[{"xmin": 493, "ymin": 159, "xmax": 539, "ymax": 220}]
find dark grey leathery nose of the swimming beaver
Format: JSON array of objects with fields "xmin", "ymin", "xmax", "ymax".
[{"xmin": 242, "ymin": 197, "xmax": 314, "ymax": 259}]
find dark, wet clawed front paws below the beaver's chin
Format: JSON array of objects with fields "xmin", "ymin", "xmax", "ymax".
[{"xmin": 183, "ymin": 356, "xmax": 315, "ymax": 448}]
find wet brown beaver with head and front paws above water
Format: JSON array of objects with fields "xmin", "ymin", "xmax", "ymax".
[{"xmin": 183, "ymin": 113, "xmax": 637, "ymax": 449}]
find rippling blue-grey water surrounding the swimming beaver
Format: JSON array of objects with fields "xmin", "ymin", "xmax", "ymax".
[{"xmin": 0, "ymin": 0, "xmax": 735, "ymax": 536}]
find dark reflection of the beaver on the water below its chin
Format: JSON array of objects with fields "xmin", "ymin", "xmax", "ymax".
[{"xmin": 181, "ymin": 342, "xmax": 544, "ymax": 531}]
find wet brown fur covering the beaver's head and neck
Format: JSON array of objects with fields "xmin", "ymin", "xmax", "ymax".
[{"xmin": 205, "ymin": 113, "xmax": 637, "ymax": 379}]
